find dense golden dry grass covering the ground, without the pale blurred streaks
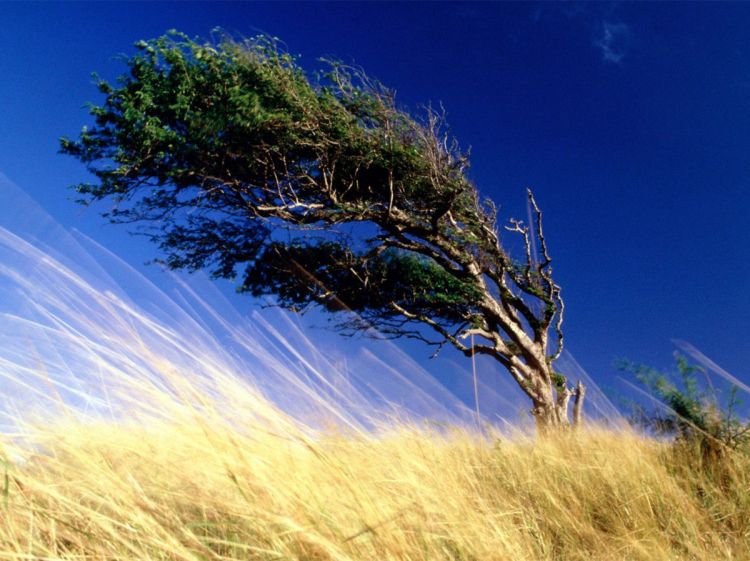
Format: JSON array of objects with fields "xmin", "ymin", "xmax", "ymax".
[{"xmin": 0, "ymin": 394, "xmax": 750, "ymax": 561}]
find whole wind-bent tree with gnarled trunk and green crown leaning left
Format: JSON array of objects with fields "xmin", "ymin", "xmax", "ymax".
[{"xmin": 61, "ymin": 32, "xmax": 585, "ymax": 429}]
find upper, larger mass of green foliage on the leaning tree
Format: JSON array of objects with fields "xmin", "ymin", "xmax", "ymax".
[{"xmin": 61, "ymin": 32, "xmax": 472, "ymax": 232}]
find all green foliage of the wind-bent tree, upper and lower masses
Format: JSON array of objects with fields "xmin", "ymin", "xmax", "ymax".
[{"xmin": 61, "ymin": 32, "xmax": 488, "ymax": 332}]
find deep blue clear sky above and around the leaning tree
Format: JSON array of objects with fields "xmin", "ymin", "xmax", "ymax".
[{"xmin": 0, "ymin": 2, "xmax": 750, "ymax": 394}]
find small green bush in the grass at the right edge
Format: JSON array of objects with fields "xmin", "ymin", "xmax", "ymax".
[{"xmin": 619, "ymin": 353, "xmax": 750, "ymax": 455}]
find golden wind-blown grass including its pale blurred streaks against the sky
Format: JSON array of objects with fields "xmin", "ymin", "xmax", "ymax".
[{"xmin": 0, "ymin": 180, "xmax": 750, "ymax": 561}]
